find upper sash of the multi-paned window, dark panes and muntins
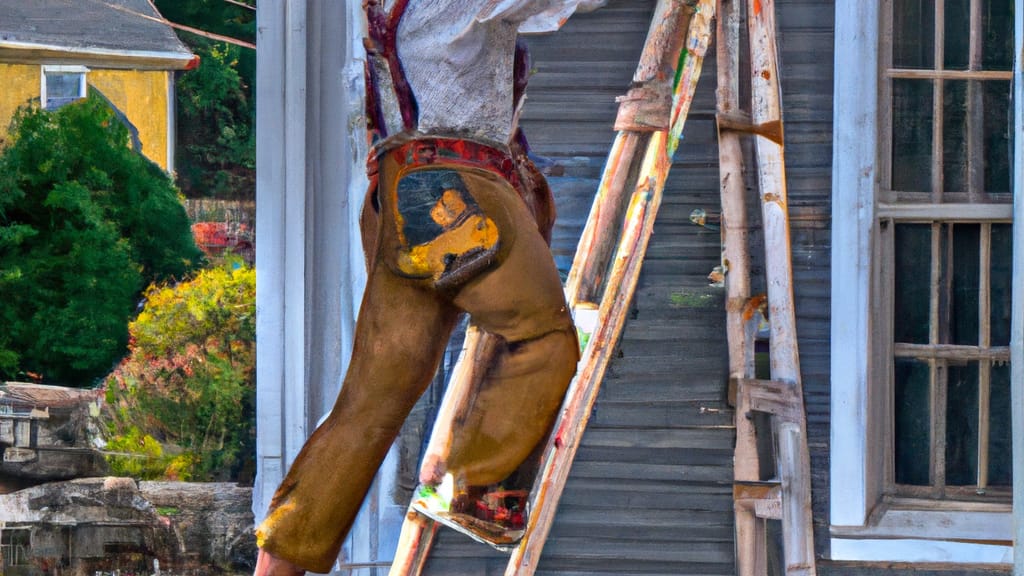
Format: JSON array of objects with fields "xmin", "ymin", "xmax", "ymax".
[{"xmin": 880, "ymin": 0, "xmax": 1014, "ymax": 203}]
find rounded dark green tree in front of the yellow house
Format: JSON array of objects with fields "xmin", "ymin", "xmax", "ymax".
[{"xmin": 0, "ymin": 96, "xmax": 203, "ymax": 385}]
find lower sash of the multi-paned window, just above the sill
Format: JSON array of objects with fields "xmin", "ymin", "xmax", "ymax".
[{"xmin": 885, "ymin": 221, "xmax": 1012, "ymax": 499}]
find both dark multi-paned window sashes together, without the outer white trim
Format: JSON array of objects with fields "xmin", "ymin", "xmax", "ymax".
[{"xmin": 876, "ymin": 0, "xmax": 1014, "ymax": 500}]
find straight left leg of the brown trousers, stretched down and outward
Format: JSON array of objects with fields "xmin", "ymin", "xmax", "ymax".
[{"xmin": 257, "ymin": 263, "xmax": 458, "ymax": 573}]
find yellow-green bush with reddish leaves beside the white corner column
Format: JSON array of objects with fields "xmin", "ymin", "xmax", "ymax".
[{"xmin": 106, "ymin": 261, "xmax": 256, "ymax": 481}]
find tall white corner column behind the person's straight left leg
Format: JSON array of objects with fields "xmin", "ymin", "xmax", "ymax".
[{"xmin": 253, "ymin": 0, "xmax": 391, "ymax": 563}]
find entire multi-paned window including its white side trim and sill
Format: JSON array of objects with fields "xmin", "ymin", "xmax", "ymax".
[{"xmin": 829, "ymin": 0, "xmax": 1021, "ymax": 563}]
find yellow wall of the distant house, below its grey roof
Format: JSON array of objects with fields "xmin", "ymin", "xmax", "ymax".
[{"xmin": 0, "ymin": 64, "xmax": 171, "ymax": 170}]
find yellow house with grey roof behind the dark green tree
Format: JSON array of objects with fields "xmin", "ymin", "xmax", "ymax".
[{"xmin": 0, "ymin": 0, "xmax": 199, "ymax": 171}]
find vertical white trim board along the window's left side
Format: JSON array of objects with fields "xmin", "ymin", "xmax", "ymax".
[{"xmin": 829, "ymin": 0, "xmax": 879, "ymax": 526}]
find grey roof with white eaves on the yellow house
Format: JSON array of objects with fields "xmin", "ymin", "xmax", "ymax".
[{"xmin": 0, "ymin": 0, "xmax": 195, "ymax": 69}]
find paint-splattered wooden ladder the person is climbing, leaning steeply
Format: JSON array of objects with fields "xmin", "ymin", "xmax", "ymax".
[{"xmin": 390, "ymin": 0, "xmax": 715, "ymax": 576}]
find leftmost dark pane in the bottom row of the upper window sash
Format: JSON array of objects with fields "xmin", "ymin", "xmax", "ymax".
[{"xmin": 892, "ymin": 78, "xmax": 934, "ymax": 192}]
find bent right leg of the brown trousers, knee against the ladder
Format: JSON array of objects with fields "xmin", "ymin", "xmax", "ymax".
[{"xmin": 447, "ymin": 165, "xmax": 580, "ymax": 486}]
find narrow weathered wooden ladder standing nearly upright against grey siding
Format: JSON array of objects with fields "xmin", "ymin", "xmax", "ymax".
[{"xmin": 716, "ymin": 0, "xmax": 815, "ymax": 576}]
